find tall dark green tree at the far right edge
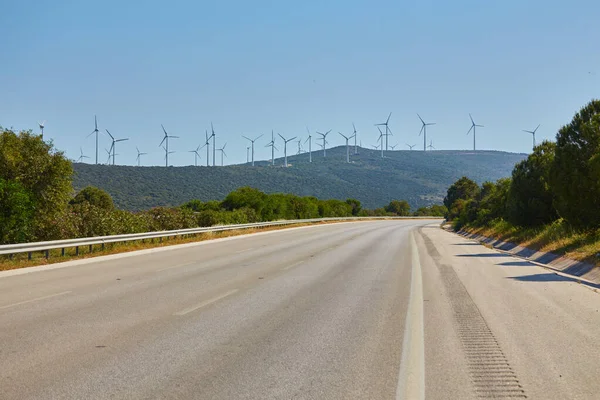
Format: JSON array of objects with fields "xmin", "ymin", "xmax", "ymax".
[{"xmin": 550, "ymin": 100, "xmax": 600, "ymax": 228}]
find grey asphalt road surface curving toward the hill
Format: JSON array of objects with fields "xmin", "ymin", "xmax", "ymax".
[{"xmin": 0, "ymin": 220, "xmax": 600, "ymax": 400}]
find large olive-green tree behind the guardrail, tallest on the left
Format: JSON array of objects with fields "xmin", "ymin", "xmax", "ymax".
[{"xmin": 0, "ymin": 128, "xmax": 73, "ymax": 239}]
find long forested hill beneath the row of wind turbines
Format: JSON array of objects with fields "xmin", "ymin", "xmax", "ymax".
[{"xmin": 73, "ymin": 146, "xmax": 526, "ymax": 210}]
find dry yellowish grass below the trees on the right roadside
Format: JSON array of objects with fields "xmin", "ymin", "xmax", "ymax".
[{"xmin": 465, "ymin": 220, "xmax": 600, "ymax": 266}]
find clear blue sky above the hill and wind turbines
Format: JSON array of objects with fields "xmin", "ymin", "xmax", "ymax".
[{"xmin": 0, "ymin": 0, "xmax": 600, "ymax": 165}]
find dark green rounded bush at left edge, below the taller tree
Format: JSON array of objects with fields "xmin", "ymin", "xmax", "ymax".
[{"xmin": 0, "ymin": 178, "xmax": 34, "ymax": 243}]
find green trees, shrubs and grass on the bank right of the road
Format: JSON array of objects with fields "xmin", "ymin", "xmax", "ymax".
[{"xmin": 444, "ymin": 100, "xmax": 600, "ymax": 265}]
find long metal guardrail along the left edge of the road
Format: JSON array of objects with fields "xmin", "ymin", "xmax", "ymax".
[{"xmin": 0, "ymin": 217, "xmax": 438, "ymax": 259}]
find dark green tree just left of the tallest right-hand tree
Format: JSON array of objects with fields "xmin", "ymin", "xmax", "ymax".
[{"xmin": 507, "ymin": 141, "xmax": 558, "ymax": 227}]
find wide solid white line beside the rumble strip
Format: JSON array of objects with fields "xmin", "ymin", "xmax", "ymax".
[{"xmin": 396, "ymin": 232, "xmax": 425, "ymax": 400}]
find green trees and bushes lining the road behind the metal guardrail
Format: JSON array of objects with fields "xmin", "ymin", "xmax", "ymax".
[{"xmin": 0, "ymin": 127, "xmax": 445, "ymax": 244}]
